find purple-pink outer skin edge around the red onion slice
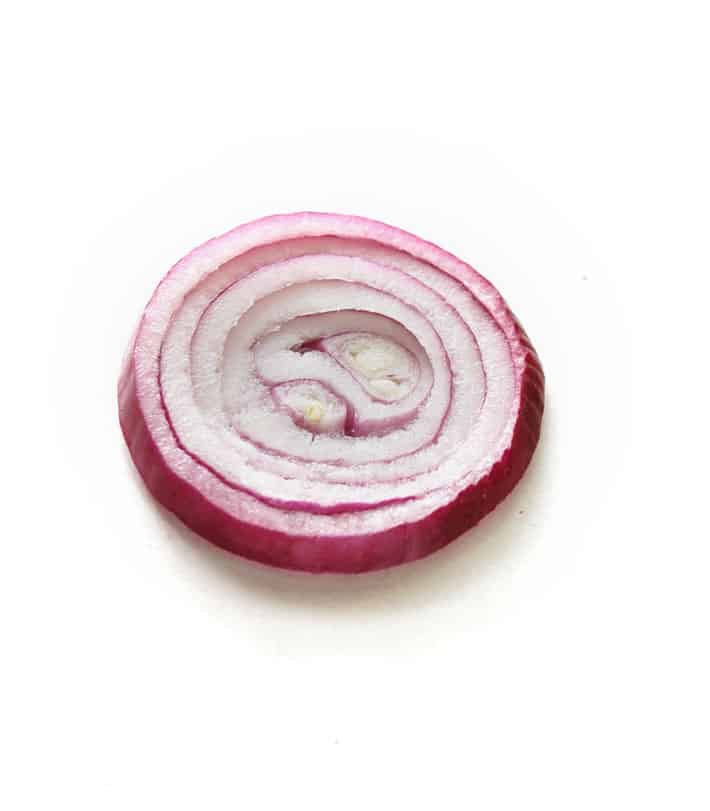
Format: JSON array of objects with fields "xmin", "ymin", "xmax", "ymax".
[{"xmin": 118, "ymin": 212, "xmax": 545, "ymax": 573}]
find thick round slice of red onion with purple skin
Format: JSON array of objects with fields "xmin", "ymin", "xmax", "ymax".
[{"xmin": 118, "ymin": 213, "xmax": 544, "ymax": 572}]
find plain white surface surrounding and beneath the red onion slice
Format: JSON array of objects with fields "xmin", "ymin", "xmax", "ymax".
[{"xmin": 0, "ymin": 0, "xmax": 710, "ymax": 811}]
